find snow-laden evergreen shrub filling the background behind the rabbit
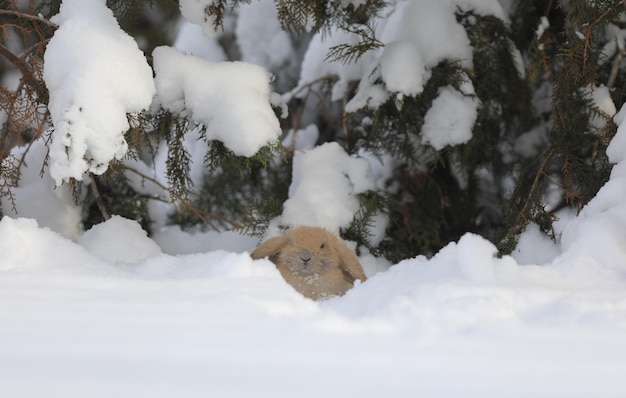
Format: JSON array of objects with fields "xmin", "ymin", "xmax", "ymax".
[{"xmin": 0, "ymin": 0, "xmax": 626, "ymax": 262}]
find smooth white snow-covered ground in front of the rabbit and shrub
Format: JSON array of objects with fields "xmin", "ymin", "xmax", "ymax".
[{"xmin": 0, "ymin": 201, "xmax": 626, "ymax": 398}]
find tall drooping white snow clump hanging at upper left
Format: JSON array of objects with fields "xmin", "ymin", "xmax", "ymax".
[{"xmin": 44, "ymin": 0, "xmax": 155, "ymax": 185}]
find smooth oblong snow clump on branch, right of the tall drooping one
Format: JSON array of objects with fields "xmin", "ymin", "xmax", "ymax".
[{"xmin": 152, "ymin": 46, "xmax": 281, "ymax": 156}]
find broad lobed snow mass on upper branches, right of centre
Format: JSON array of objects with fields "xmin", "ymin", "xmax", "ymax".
[{"xmin": 294, "ymin": 0, "xmax": 507, "ymax": 129}]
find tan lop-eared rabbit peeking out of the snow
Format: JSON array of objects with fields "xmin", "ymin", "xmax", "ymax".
[{"xmin": 251, "ymin": 226, "xmax": 367, "ymax": 300}]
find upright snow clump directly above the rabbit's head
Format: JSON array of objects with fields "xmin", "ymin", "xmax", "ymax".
[{"xmin": 278, "ymin": 142, "xmax": 376, "ymax": 232}]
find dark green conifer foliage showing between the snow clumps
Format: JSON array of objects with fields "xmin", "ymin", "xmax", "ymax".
[{"xmin": 0, "ymin": 0, "xmax": 626, "ymax": 262}]
